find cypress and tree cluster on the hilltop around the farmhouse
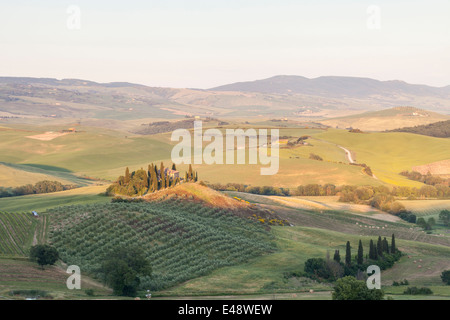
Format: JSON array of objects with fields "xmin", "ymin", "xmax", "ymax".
[{"xmin": 107, "ymin": 162, "xmax": 198, "ymax": 196}]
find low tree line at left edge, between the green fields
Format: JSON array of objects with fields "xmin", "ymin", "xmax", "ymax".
[{"xmin": 0, "ymin": 180, "xmax": 77, "ymax": 198}]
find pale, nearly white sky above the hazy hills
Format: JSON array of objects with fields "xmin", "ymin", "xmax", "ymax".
[{"xmin": 0, "ymin": 0, "xmax": 450, "ymax": 88}]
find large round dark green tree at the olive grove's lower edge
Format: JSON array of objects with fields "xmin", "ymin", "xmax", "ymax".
[{"xmin": 99, "ymin": 247, "xmax": 152, "ymax": 297}]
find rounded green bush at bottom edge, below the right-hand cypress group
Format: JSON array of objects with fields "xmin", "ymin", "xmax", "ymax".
[{"xmin": 332, "ymin": 276, "xmax": 384, "ymax": 300}]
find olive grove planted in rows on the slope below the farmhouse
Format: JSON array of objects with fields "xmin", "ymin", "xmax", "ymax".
[{"xmin": 48, "ymin": 200, "xmax": 276, "ymax": 291}]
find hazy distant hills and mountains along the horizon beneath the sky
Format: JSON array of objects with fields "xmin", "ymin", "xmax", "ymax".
[{"xmin": 0, "ymin": 76, "xmax": 450, "ymax": 121}]
